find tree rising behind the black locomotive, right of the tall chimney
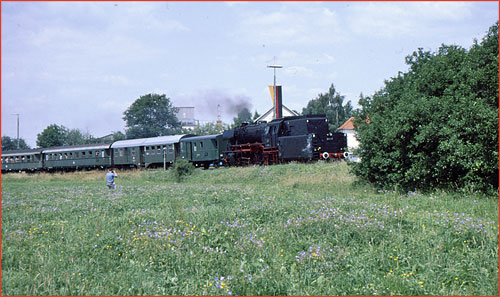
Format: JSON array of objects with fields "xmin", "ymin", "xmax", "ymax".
[{"xmin": 302, "ymin": 84, "xmax": 353, "ymax": 131}]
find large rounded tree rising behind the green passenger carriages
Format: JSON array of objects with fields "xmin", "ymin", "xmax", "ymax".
[{"xmin": 123, "ymin": 94, "xmax": 181, "ymax": 139}]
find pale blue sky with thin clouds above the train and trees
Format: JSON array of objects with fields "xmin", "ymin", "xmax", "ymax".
[{"xmin": 1, "ymin": 1, "xmax": 499, "ymax": 147}]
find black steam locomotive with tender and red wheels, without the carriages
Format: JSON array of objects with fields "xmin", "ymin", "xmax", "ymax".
[{"xmin": 223, "ymin": 115, "xmax": 347, "ymax": 166}]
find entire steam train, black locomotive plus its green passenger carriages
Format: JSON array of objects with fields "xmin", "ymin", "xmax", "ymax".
[{"xmin": 1, "ymin": 115, "xmax": 347, "ymax": 172}]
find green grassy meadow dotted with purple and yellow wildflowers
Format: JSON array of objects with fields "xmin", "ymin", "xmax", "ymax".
[{"xmin": 1, "ymin": 163, "xmax": 499, "ymax": 296}]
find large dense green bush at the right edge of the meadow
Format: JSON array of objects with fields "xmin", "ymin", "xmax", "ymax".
[{"xmin": 353, "ymin": 23, "xmax": 498, "ymax": 191}]
